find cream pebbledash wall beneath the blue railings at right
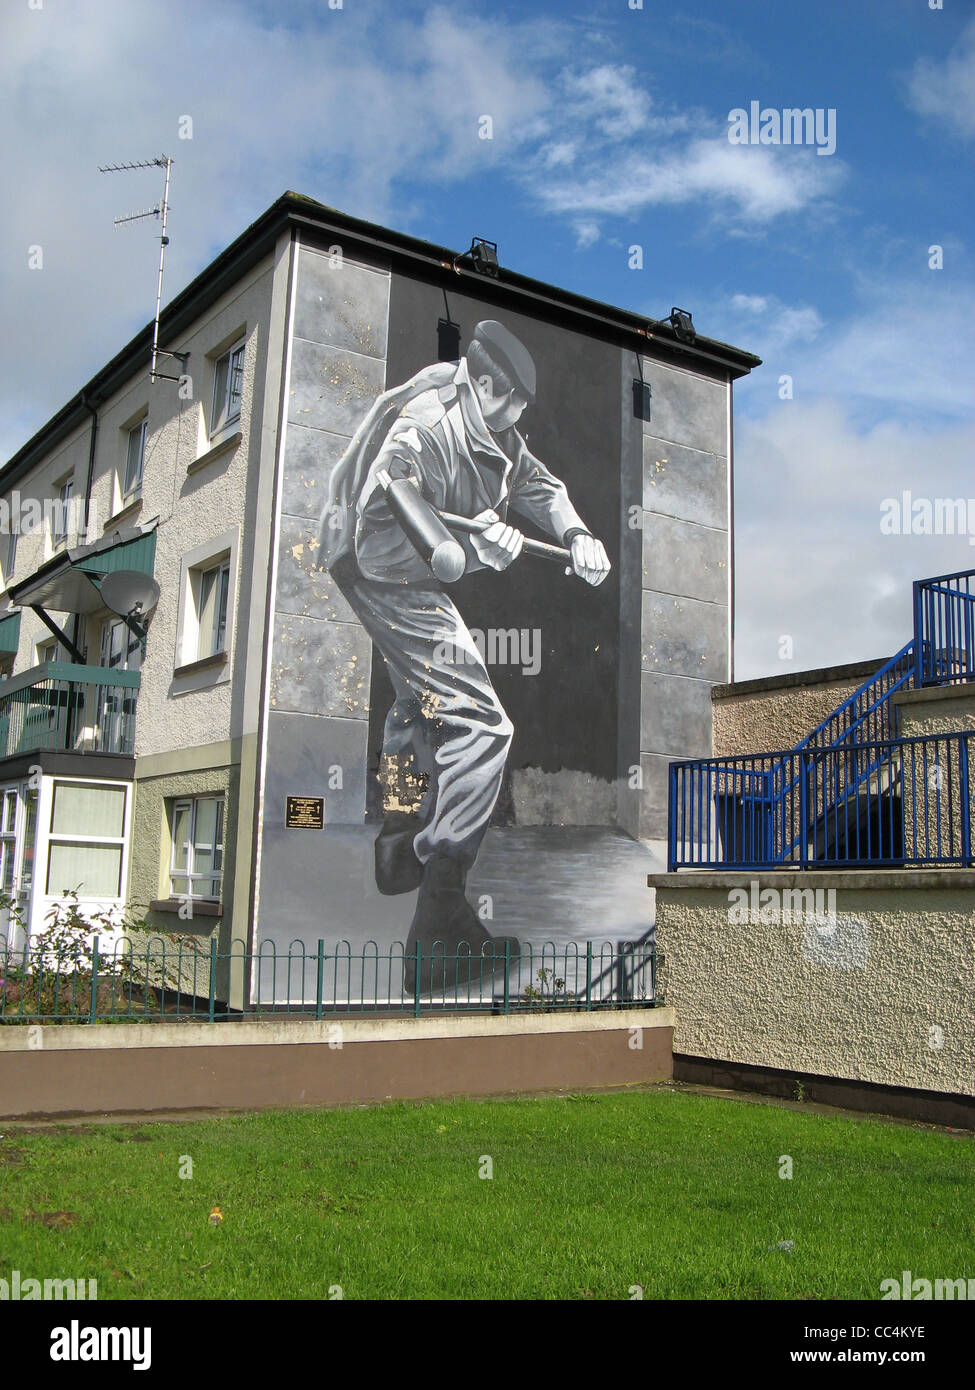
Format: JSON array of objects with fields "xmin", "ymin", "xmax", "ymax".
[{"xmin": 650, "ymin": 678, "xmax": 975, "ymax": 1100}]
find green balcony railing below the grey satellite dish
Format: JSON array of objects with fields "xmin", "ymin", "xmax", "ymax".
[{"xmin": 0, "ymin": 662, "xmax": 140, "ymax": 758}]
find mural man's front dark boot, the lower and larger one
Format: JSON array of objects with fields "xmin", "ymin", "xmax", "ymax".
[{"xmin": 403, "ymin": 855, "xmax": 519, "ymax": 994}]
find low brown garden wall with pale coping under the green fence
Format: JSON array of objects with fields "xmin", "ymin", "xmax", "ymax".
[{"xmin": 0, "ymin": 1008, "xmax": 673, "ymax": 1119}]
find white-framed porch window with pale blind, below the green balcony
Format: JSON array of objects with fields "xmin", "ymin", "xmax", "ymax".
[{"xmin": 46, "ymin": 781, "xmax": 125, "ymax": 898}]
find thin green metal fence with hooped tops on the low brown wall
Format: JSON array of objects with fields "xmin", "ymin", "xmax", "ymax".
[{"xmin": 0, "ymin": 937, "xmax": 661, "ymax": 1023}]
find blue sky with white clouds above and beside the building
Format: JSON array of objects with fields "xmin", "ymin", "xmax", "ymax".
[{"xmin": 0, "ymin": 0, "xmax": 975, "ymax": 678}]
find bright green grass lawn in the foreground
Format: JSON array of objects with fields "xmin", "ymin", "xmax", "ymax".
[{"xmin": 0, "ymin": 1088, "xmax": 975, "ymax": 1298}]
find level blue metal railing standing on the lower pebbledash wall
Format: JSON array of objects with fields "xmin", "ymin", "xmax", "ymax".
[{"xmin": 668, "ymin": 733, "xmax": 975, "ymax": 870}]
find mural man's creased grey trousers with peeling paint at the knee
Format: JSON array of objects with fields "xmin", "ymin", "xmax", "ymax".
[{"xmin": 332, "ymin": 566, "xmax": 513, "ymax": 865}]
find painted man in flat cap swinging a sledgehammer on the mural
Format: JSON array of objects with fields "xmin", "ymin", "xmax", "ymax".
[{"xmin": 319, "ymin": 320, "xmax": 609, "ymax": 991}]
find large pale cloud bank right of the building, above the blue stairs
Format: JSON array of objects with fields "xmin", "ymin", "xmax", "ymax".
[{"xmin": 736, "ymin": 400, "xmax": 975, "ymax": 680}]
